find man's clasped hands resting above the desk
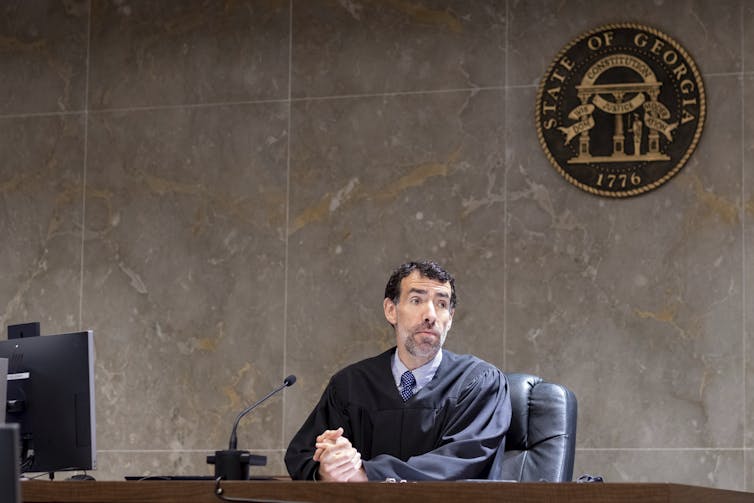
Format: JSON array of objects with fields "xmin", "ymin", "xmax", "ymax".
[{"xmin": 312, "ymin": 428, "xmax": 368, "ymax": 482}]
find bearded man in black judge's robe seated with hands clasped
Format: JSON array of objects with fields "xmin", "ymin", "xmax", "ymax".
[{"xmin": 285, "ymin": 262, "xmax": 511, "ymax": 482}]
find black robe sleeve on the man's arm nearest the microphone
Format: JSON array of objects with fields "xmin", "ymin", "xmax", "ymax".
[{"xmin": 285, "ymin": 381, "xmax": 350, "ymax": 480}]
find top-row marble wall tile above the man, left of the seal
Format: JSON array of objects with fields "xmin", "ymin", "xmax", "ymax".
[{"xmin": 292, "ymin": 0, "xmax": 506, "ymax": 97}]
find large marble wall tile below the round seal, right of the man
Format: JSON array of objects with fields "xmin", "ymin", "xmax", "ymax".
[{"xmin": 506, "ymin": 77, "xmax": 743, "ymax": 447}]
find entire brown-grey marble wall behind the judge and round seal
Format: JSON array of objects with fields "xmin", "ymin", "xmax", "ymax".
[{"xmin": 0, "ymin": 0, "xmax": 754, "ymax": 490}]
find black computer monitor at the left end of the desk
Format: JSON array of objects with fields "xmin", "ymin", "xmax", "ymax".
[{"xmin": 0, "ymin": 331, "xmax": 97, "ymax": 473}]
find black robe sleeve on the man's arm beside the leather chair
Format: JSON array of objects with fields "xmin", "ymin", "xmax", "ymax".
[{"xmin": 363, "ymin": 365, "xmax": 511, "ymax": 481}]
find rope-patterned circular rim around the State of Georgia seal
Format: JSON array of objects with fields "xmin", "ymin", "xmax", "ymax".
[{"xmin": 535, "ymin": 23, "xmax": 707, "ymax": 198}]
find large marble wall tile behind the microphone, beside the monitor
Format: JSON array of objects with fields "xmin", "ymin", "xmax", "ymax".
[{"xmin": 84, "ymin": 103, "xmax": 288, "ymax": 450}]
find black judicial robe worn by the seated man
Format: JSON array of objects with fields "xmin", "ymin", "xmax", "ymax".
[{"xmin": 285, "ymin": 347, "xmax": 511, "ymax": 480}]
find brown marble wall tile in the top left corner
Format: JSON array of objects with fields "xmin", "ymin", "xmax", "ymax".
[{"xmin": 0, "ymin": 0, "xmax": 89, "ymax": 114}]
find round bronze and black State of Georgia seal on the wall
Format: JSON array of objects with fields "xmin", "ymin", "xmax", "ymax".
[{"xmin": 536, "ymin": 23, "xmax": 705, "ymax": 197}]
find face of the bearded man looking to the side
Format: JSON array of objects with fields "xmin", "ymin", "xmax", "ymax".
[{"xmin": 383, "ymin": 271, "xmax": 454, "ymax": 369}]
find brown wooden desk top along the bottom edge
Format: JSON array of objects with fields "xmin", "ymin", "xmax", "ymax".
[{"xmin": 21, "ymin": 480, "xmax": 754, "ymax": 503}]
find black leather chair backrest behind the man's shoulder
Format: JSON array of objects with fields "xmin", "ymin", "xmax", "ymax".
[{"xmin": 489, "ymin": 374, "xmax": 577, "ymax": 482}]
